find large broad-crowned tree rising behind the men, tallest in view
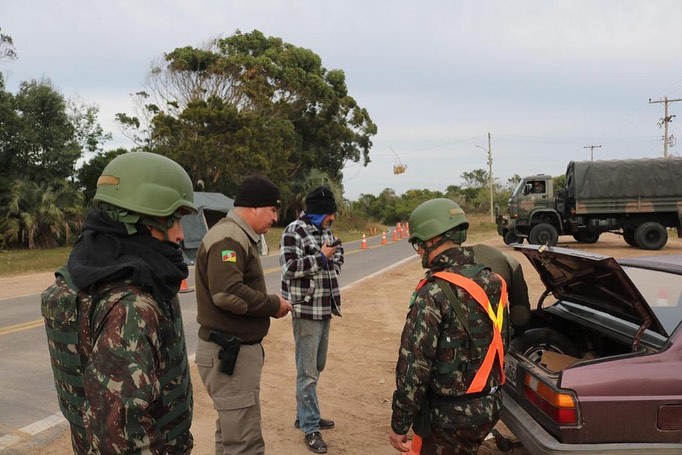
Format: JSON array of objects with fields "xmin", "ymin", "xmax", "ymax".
[{"xmin": 118, "ymin": 30, "xmax": 377, "ymax": 200}]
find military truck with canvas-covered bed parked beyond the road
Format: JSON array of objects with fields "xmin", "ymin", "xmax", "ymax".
[{"xmin": 495, "ymin": 158, "xmax": 682, "ymax": 250}]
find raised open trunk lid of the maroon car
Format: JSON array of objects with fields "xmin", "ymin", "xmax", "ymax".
[{"xmin": 514, "ymin": 245, "xmax": 669, "ymax": 338}]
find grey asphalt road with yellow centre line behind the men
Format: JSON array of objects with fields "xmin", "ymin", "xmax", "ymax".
[{"xmin": 0, "ymin": 235, "xmax": 415, "ymax": 453}]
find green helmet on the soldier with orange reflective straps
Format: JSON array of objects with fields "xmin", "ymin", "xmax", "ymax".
[{"xmin": 409, "ymin": 198, "xmax": 469, "ymax": 243}]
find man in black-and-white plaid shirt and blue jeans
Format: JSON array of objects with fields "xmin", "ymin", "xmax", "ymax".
[{"xmin": 279, "ymin": 186, "xmax": 343, "ymax": 453}]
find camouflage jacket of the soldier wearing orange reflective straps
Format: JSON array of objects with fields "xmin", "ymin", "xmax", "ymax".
[{"xmin": 391, "ymin": 247, "xmax": 508, "ymax": 434}]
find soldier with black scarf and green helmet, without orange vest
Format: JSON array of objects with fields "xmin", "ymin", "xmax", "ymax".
[{"xmin": 41, "ymin": 152, "xmax": 196, "ymax": 454}]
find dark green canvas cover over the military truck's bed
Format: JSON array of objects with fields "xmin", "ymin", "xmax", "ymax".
[{"xmin": 566, "ymin": 158, "xmax": 682, "ymax": 199}]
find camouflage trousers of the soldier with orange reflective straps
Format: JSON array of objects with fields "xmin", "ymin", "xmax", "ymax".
[{"xmin": 420, "ymin": 391, "xmax": 501, "ymax": 455}]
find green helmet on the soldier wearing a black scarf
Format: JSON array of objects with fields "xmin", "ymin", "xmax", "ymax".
[{"xmin": 93, "ymin": 152, "xmax": 197, "ymax": 217}]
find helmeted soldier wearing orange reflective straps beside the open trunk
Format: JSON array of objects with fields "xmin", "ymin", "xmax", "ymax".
[{"xmin": 389, "ymin": 198, "xmax": 508, "ymax": 455}]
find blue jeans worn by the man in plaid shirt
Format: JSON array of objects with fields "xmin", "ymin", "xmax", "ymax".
[{"xmin": 292, "ymin": 318, "xmax": 331, "ymax": 434}]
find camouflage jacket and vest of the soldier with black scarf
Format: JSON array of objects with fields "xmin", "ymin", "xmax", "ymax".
[{"xmin": 41, "ymin": 272, "xmax": 193, "ymax": 454}]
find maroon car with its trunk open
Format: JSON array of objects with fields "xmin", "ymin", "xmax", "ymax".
[{"xmin": 502, "ymin": 245, "xmax": 682, "ymax": 455}]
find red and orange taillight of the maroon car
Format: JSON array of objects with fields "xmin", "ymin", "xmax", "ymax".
[{"xmin": 523, "ymin": 373, "xmax": 578, "ymax": 425}]
